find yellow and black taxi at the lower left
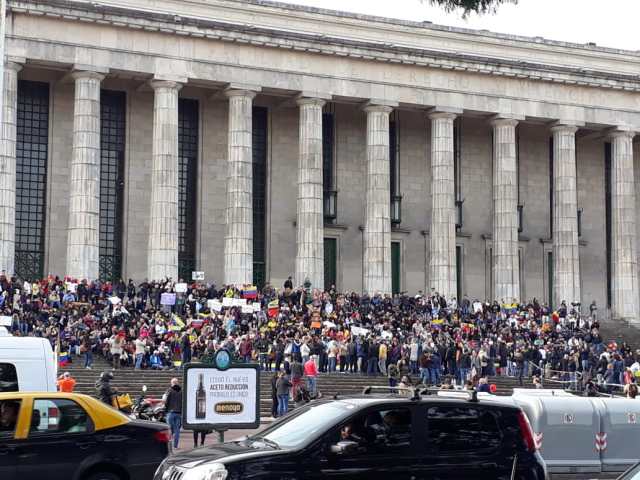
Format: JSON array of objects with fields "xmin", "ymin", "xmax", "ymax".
[{"xmin": 0, "ymin": 392, "xmax": 170, "ymax": 480}]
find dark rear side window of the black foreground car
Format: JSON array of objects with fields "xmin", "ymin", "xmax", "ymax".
[{"xmin": 427, "ymin": 406, "xmax": 502, "ymax": 453}]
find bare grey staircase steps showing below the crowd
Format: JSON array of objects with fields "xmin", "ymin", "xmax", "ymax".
[{"xmin": 60, "ymin": 356, "xmax": 532, "ymax": 417}]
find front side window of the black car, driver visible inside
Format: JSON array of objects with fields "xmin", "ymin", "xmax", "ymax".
[{"xmin": 330, "ymin": 408, "xmax": 411, "ymax": 455}]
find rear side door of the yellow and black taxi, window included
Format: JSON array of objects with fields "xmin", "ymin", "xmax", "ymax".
[{"xmin": 17, "ymin": 398, "xmax": 99, "ymax": 480}]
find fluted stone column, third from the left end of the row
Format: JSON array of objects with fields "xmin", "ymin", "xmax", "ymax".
[{"xmin": 147, "ymin": 80, "xmax": 182, "ymax": 281}]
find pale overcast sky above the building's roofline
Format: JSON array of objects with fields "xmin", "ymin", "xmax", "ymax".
[{"xmin": 282, "ymin": 0, "xmax": 640, "ymax": 50}]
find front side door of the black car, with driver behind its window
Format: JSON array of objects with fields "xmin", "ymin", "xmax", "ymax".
[{"xmin": 301, "ymin": 404, "xmax": 416, "ymax": 480}]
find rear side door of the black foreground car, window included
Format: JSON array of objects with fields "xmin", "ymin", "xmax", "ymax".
[{"xmin": 417, "ymin": 403, "xmax": 510, "ymax": 480}]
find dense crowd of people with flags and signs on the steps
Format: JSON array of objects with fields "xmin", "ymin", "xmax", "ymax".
[{"xmin": 0, "ymin": 276, "xmax": 640, "ymax": 414}]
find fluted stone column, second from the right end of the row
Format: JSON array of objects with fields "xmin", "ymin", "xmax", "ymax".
[{"xmin": 551, "ymin": 125, "xmax": 580, "ymax": 308}]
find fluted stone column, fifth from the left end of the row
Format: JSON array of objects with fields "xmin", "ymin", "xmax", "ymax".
[{"xmin": 295, "ymin": 98, "xmax": 325, "ymax": 288}]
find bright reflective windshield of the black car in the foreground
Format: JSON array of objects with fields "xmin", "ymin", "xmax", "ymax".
[{"xmin": 251, "ymin": 402, "xmax": 355, "ymax": 448}]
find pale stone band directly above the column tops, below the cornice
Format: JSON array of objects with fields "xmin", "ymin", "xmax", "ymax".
[{"xmin": 7, "ymin": 0, "xmax": 640, "ymax": 129}]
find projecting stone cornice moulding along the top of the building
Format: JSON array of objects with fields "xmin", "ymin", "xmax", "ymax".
[{"xmin": 8, "ymin": 0, "xmax": 640, "ymax": 91}]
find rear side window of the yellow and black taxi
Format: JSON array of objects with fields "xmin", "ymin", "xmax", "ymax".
[{"xmin": 30, "ymin": 398, "xmax": 93, "ymax": 435}]
